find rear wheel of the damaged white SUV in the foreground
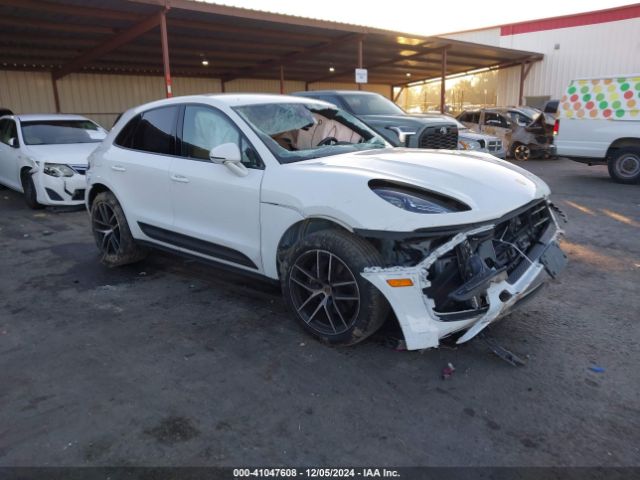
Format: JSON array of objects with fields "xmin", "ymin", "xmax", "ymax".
[{"xmin": 91, "ymin": 192, "xmax": 146, "ymax": 267}]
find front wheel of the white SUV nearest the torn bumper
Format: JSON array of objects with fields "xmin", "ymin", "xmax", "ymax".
[{"xmin": 280, "ymin": 230, "xmax": 389, "ymax": 345}]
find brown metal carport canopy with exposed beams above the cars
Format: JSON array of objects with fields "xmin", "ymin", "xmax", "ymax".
[{"xmin": 0, "ymin": 0, "xmax": 542, "ymax": 103}]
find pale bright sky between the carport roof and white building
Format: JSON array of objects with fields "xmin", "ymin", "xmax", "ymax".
[{"xmin": 214, "ymin": 0, "xmax": 634, "ymax": 35}]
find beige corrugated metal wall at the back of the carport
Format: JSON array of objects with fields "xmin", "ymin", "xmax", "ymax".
[{"xmin": 0, "ymin": 70, "xmax": 390, "ymax": 128}]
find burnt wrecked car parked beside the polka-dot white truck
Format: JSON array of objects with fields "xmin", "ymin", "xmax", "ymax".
[{"xmin": 457, "ymin": 107, "xmax": 555, "ymax": 161}]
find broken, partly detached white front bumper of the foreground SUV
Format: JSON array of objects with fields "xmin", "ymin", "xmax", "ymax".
[{"xmin": 362, "ymin": 202, "xmax": 566, "ymax": 350}]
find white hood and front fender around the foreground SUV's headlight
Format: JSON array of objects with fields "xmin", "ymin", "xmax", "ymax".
[{"xmin": 262, "ymin": 148, "xmax": 549, "ymax": 231}]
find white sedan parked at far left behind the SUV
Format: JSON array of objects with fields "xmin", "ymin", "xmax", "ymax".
[{"xmin": 0, "ymin": 115, "xmax": 107, "ymax": 208}]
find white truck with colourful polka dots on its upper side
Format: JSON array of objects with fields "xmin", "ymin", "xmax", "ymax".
[{"xmin": 554, "ymin": 73, "xmax": 640, "ymax": 183}]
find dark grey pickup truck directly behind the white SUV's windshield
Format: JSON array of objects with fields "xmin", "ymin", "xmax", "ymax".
[{"xmin": 293, "ymin": 90, "xmax": 458, "ymax": 150}]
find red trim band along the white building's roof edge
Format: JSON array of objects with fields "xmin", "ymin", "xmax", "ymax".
[{"xmin": 500, "ymin": 3, "xmax": 640, "ymax": 37}]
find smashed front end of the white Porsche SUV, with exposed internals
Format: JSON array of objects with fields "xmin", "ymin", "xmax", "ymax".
[{"xmin": 358, "ymin": 200, "xmax": 566, "ymax": 349}]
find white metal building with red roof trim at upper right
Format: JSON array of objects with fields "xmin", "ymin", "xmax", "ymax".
[{"xmin": 441, "ymin": 4, "xmax": 640, "ymax": 105}]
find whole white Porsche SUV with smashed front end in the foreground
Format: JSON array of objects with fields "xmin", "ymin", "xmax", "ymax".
[{"xmin": 86, "ymin": 94, "xmax": 564, "ymax": 349}]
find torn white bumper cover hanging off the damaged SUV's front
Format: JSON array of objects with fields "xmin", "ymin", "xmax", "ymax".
[{"xmin": 361, "ymin": 205, "xmax": 566, "ymax": 350}]
